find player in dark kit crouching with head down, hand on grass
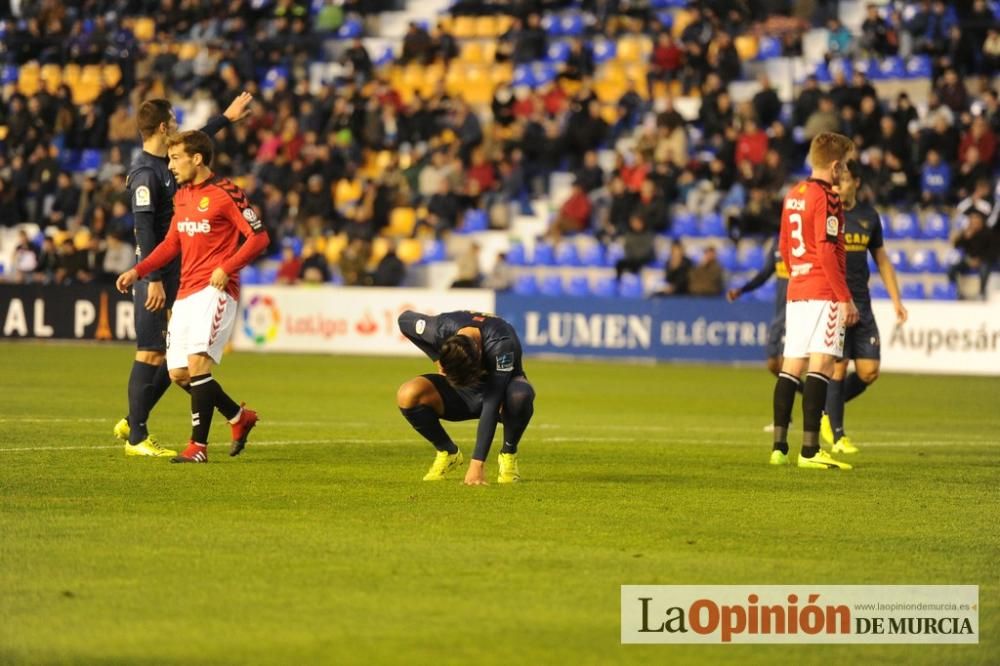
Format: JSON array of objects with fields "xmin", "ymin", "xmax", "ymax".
[{"xmin": 396, "ymin": 310, "xmax": 535, "ymax": 486}]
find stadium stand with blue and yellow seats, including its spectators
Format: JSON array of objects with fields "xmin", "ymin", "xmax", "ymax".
[{"xmin": 0, "ymin": 0, "xmax": 1000, "ymax": 298}]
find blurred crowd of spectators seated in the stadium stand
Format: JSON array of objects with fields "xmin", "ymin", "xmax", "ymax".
[{"xmin": 0, "ymin": 0, "xmax": 1000, "ymax": 294}]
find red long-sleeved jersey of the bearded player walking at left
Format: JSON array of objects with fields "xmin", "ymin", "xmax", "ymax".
[{"xmin": 135, "ymin": 175, "xmax": 268, "ymax": 299}]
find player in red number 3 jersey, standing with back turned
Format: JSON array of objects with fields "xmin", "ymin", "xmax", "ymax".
[{"xmin": 771, "ymin": 132, "xmax": 858, "ymax": 469}]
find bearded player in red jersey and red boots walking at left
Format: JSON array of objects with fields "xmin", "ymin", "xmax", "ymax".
[{"xmin": 117, "ymin": 131, "xmax": 268, "ymax": 463}]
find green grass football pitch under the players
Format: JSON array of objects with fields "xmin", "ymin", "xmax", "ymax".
[{"xmin": 0, "ymin": 343, "xmax": 1000, "ymax": 664}]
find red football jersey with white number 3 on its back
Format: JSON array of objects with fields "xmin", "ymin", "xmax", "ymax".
[{"xmin": 779, "ymin": 178, "xmax": 851, "ymax": 302}]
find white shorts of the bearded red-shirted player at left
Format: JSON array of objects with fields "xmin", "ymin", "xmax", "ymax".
[{"xmin": 167, "ymin": 286, "xmax": 237, "ymax": 370}]
